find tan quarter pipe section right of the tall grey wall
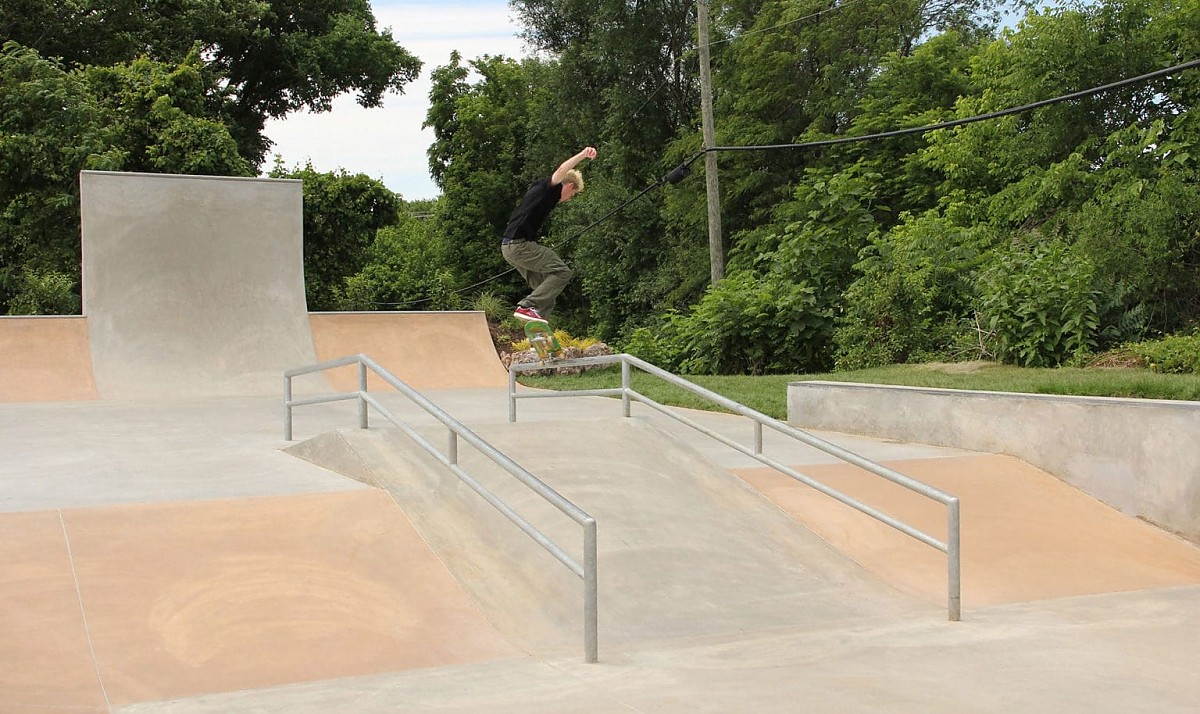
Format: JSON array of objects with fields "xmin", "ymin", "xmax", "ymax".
[{"xmin": 310, "ymin": 312, "xmax": 509, "ymax": 391}]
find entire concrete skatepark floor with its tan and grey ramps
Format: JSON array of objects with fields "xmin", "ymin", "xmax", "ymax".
[{"xmin": 0, "ymin": 173, "xmax": 1200, "ymax": 713}]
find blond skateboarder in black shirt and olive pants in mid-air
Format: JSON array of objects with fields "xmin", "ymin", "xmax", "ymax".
[{"xmin": 500, "ymin": 146, "xmax": 596, "ymax": 323}]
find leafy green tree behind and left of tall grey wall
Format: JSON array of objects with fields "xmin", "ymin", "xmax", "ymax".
[{"xmin": 0, "ymin": 42, "xmax": 262, "ymax": 311}]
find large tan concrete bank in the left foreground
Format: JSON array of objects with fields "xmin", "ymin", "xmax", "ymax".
[{"xmin": 0, "ymin": 488, "xmax": 522, "ymax": 713}]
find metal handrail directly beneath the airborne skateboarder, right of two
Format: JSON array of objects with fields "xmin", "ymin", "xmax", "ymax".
[{"xmin": 509, "ymin": 354, "xmax": 962, "ymax": 622}]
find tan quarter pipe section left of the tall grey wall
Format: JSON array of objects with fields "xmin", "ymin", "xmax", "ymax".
[{"xmin": 0, "ymin": 317, "xmax": 96, "ymax": 402}]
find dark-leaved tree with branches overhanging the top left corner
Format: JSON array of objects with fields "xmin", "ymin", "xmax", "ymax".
[{"xmin": 0, "ymin": 0, "xmax": 421, "ymax": 167}]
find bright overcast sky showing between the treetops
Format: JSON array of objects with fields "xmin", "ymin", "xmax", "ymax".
[{"xmin": 263, "ymin": 0, "xmax": 524, "ymax": 200}]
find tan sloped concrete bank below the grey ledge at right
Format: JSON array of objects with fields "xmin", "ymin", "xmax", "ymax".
[{"xmin": 736, "ymin": 454, "xmax": 1200, "ymax": 612}]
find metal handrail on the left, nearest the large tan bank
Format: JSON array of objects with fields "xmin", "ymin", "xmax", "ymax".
[{"xmin": 283, "ymin": 354, "xmax": 599, "ymax": 662}]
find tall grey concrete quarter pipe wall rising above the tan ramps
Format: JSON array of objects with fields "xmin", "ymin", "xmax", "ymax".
[{"xmin": 79, "ymin": 172, "xmax": 317, "ymax": 398}]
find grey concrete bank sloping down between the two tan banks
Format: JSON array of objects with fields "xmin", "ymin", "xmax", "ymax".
[{"xmin": 289, "ymin": 418, "xmax": 931, "ymax": 661}]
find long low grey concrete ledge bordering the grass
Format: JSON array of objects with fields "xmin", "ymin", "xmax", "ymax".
[{"xmin": 787, "ymin": 382, "xmax": 1200, "ymax": 542}]
